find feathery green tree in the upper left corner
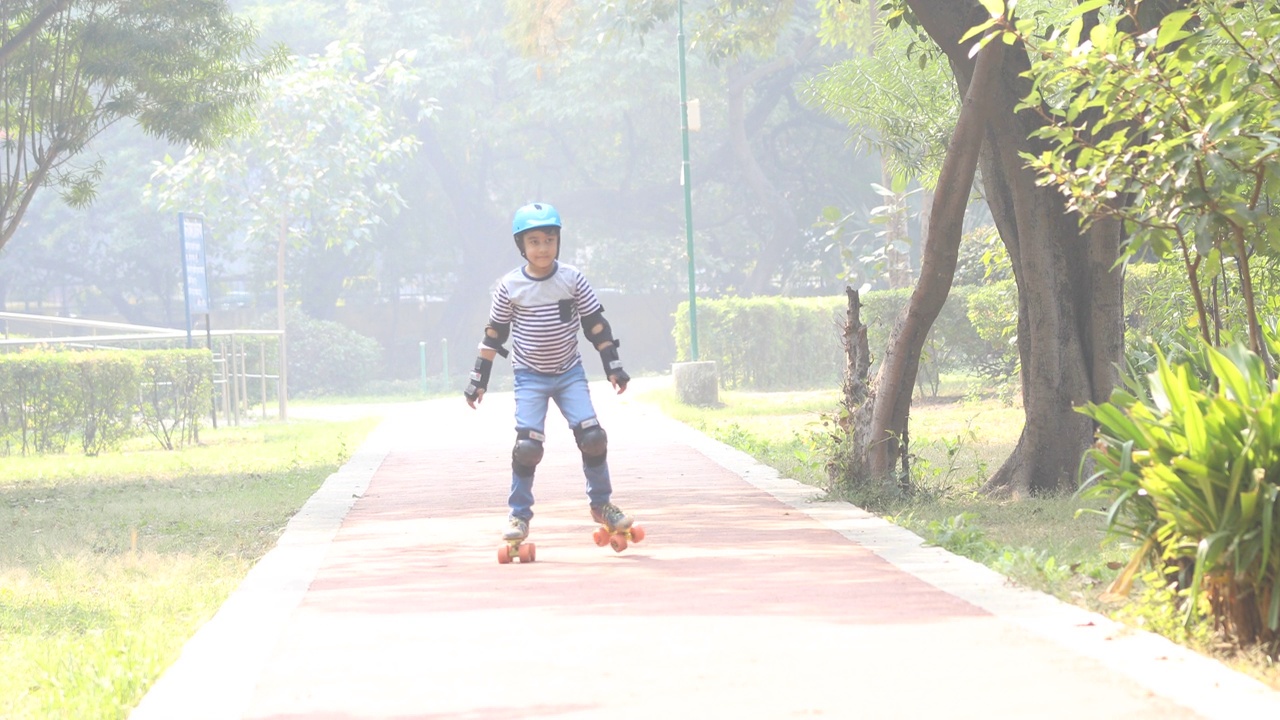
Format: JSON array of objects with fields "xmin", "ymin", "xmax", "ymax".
[{"xmin": 0, "ymin": 0, "xmax": 282, "ymax": 247}]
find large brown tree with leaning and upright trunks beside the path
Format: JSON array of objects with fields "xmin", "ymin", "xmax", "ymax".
[{"xmin": 829, "ymin": 0, "xmax": 1141, "ymax": 495}]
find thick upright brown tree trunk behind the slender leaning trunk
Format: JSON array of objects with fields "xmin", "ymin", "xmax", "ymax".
[{"xmin": 908, "ymin": 0, "xmax": 1123, "ymax": 496}]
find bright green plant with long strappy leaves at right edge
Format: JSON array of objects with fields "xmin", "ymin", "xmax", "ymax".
[{"xmin": 1080, "ymin": 343, "xmax": 1280, "ymax": 652}]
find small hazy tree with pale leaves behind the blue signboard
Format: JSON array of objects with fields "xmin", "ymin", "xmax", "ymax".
[{"xmin": 154, "ymin": 42, "xmax": 419, "ymax": 319}]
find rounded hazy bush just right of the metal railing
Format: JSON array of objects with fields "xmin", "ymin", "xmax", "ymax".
[{"xmin": 287, "ymin": 313, "xmax": 383, "ymax": 396}]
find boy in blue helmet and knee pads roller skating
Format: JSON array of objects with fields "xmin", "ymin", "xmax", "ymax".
[{"xmin": 463, "ymin": 202, "xmax": 634, "ymax": 542}]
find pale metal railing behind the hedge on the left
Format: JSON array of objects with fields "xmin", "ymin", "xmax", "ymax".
[{"xmin": 0, "ymin": 313, "xmax": 288, "ymax": 428}]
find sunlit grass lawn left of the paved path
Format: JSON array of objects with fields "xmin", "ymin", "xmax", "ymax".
[{"xmin": 0, "ymin": 419, "xmax": 376, "ymax": 720}]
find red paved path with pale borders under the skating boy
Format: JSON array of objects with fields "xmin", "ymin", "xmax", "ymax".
[{"xmin": 132, "ymin": 386, "xmax": 1280, "ymax": 720}]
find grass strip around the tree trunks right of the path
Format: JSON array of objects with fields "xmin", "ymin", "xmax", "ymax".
[{"xmin": 641, "ymin": 379, "xmax": 1280, "ymax": 689}]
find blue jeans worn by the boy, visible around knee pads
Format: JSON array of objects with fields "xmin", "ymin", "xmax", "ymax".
[{"xmin": 507, "ymin": 363, "xmax": 613, "ymax": 521}]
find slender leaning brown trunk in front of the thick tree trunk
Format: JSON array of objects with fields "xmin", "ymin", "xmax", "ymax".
[{"xmin": 855, "ymin": 33, "xmax": 1005, "ymax": 482}]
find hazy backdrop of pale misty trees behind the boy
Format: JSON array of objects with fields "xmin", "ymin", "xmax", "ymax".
[{"xmin": 0, "ymin": 0, "xmax": 901, "ymax": 379}]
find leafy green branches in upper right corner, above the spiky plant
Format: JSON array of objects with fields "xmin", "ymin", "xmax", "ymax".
[{"xmin": 1005, "ymin": 0, "xmax": 1280, "ymax": 352}]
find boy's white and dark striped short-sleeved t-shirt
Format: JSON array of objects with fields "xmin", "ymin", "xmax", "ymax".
[{"xmin": 489, "ymin": 263, "xmax": 602, "ymax": 374}]
